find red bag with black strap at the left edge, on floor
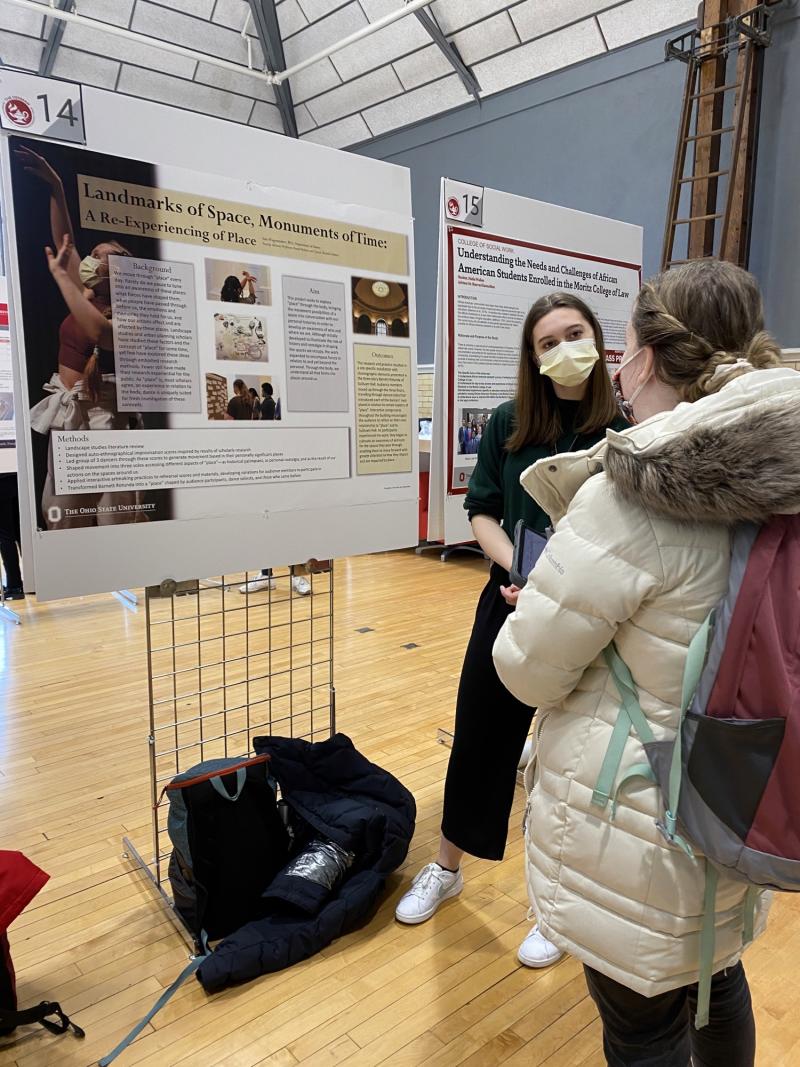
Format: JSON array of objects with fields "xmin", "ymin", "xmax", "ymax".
[{"xmin": 0, "ymin": 850, "xmax": 84, "ymax": 1037}]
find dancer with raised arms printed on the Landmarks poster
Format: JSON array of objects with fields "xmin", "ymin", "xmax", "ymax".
[{"xmin": 15, "ymin": 147, "xmax": 143, "ymax": 529}]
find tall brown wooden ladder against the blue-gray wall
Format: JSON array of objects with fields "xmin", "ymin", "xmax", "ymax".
[{"xmin": 661, "ymin": 0, "xmax": 780, "ymax": 270}]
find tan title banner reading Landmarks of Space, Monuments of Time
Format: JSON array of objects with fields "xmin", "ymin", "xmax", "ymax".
[{"xmin": 78, "ymin": 174, "xmax": 409, "ymax": 275}]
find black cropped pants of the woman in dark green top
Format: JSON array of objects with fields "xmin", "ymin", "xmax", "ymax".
[{"xmin": 442, "ymin": 563, "xmax": 534, "ymax": 860}]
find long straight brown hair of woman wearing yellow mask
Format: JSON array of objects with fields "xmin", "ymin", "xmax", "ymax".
[{"xmin": 506, "ymin": 292, "xmax": 620, "ymax": 452}]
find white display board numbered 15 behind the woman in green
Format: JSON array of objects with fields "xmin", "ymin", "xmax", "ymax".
[{"xmin": 429, "ymin": 178, "xmax": 642, "ymax": 544}]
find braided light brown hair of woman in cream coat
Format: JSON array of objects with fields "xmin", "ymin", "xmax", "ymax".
[{"xmin": 631, "ymin": 259, "xmax": 781, "ymax": 401}]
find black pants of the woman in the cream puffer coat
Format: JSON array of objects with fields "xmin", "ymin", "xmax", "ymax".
[{"xmin": 583, "ymin": 964, "xmax": 755, "ymax": 1067}]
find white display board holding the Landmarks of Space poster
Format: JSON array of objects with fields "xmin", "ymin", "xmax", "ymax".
[{"xmin": 4, "ymin": 92, "xmax": 418, "ymax": 600}]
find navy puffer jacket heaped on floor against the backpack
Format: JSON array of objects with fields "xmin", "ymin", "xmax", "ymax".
[{"xmin": 197, "ymin": 734, "xmax": 416, "ymax": 992}]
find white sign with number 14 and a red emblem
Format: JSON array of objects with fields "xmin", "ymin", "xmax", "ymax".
[{"xmin": 0, "ymin": 67, "xmax": 86, "ymax": 144}]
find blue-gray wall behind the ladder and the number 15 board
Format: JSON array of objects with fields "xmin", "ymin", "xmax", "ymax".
[{"xmin": 357, "ymin": 4, "xmax": 800, "ymax": 363}]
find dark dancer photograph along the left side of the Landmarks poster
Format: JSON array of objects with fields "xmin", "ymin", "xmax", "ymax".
[{"xmin": 10, "ymin": 137, "xmax": 173, "ymax": 530}]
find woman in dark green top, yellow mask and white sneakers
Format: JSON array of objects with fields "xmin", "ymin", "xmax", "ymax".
[{"xmin": 396, "ymin": 293, "xmax": 625, "ymax": 967}]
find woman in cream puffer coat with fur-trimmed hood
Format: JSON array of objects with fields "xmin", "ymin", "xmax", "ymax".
[{"xmin": 494, "ymin": 259, "xmax": 800, "ymax": 1067}]
